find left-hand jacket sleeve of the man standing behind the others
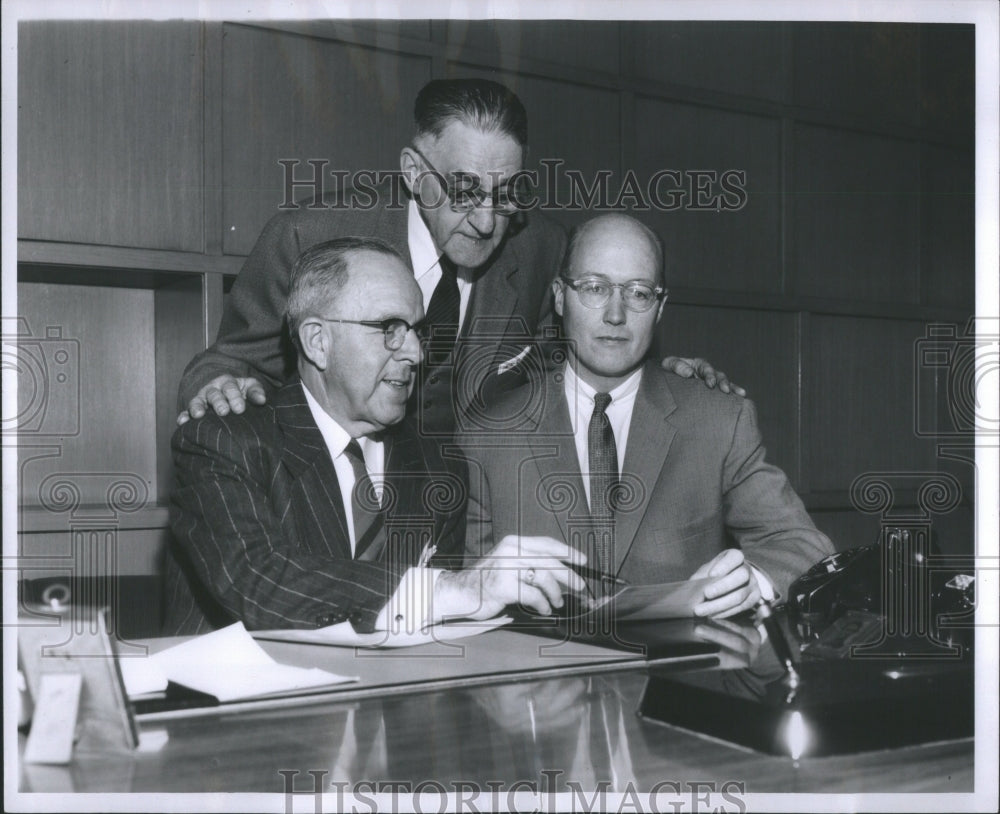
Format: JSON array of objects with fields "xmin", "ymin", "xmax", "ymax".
[{"xmin": 178, "ymin": 212, "xmax": 300, "ymax": 410}]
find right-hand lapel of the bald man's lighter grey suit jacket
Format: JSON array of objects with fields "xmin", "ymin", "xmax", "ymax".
[{"xmin": 614, "ymin": 363, "xmax": 677, "ymax": 573}]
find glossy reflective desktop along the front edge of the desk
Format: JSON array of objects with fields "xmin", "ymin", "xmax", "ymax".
[{"xmin": 15, "ymin": 620, "xmax": 974, "ymax": 810}]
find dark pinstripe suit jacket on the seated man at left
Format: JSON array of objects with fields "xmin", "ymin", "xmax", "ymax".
[{"xmin": 166, "ymin": 380, "xmax": 466, "ymax": 634}]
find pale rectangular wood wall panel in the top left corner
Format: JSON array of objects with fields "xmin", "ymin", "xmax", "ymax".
[{"xmin": 17, "ymin": 21, "xmax": 205, "ymax": 252}]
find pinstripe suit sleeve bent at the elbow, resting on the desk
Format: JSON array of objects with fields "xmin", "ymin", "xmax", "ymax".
[{"xmin": 171, "ymin": 417, "xmax": 403, "ymax": 631}]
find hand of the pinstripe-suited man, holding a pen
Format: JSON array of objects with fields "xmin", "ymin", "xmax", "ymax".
[{"xmin": 434, "ymin": 534, "xmax": 587, "ymax": 621}]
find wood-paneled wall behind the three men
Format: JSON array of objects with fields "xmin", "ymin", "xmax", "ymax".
[{"xmin": 18, "ymin": 21, "xmax": 975, "ymax": 568}]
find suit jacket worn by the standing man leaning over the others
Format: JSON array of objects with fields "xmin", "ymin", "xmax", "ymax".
[{"xmin": 179, "ymin": 187, "xmax": 566, "ymax": 435}]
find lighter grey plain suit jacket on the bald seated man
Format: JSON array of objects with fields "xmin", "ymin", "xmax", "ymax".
[{"xmin": 459, "ymin": 362, "xmax": 833, "ymax": 594}]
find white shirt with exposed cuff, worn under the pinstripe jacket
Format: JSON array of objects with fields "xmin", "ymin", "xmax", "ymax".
[{"xmin": 302, "ymin": 382, "xmax": 441, "ymax": 633}]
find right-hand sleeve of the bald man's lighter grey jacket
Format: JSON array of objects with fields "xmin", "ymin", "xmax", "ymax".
[{"xmin": 723, "ymin": 400, "xmax": 834, "ymax": 596}]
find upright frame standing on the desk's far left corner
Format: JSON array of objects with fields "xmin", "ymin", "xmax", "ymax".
[{"xmin": 17, "ymin": 605, "xmax": 139, "ymax": 762}]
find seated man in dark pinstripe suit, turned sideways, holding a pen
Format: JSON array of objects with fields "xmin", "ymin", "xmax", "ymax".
[{"xmin": 166, "ymin": 237, "xmax": 583, "ymax": 634}]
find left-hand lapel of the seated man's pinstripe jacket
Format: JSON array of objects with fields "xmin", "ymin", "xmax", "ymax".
[{"xmin": 272, "ymin": 379, "xmax": 352, "ymax": 559}]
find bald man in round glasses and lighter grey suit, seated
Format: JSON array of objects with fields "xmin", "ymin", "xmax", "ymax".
[{"xmin": 460, "ymin": 215, "xmax": 833, "ymax": 617}]
